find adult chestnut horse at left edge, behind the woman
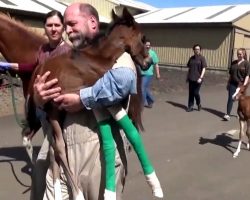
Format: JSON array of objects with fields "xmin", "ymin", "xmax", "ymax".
[{"xmin": 0, "ymin": 13, "xmax": 47, "ymax": 160}]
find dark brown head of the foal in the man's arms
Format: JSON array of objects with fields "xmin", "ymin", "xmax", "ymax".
[{"xmin": 109, "ymin": 8, "xmax": 148, "ymax": 68}]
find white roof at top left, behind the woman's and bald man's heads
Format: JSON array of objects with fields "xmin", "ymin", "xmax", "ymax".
[{"xmin": 0, "ymin": 0, "xmax": 110, "ymax": 23}]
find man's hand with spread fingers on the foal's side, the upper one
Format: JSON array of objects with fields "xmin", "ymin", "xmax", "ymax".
[{"xmin": 33, "ymin": 72, "xmax": 61, "ymax": 106}]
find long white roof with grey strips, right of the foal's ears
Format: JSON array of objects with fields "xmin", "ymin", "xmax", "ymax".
[{"xmin": 135, "ymin": 4, "xmax": 250, "ymax": 23}]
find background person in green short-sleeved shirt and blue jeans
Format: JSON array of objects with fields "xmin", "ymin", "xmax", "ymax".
[{"xmin": 141, "ymin": 39, "xmax": 160, "ymax": 108}]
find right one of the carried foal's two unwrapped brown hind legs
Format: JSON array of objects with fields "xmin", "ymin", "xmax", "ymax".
[{"xmin": 50, "ymin": 116, "xmax": 85, "ymax": 200}]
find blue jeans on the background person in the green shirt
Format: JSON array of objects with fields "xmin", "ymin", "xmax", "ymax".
[{"xmin": 142, "ymin": 75, "xmax": 155, "ymax": 106}]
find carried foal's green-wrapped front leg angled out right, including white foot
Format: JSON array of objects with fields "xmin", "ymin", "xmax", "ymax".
[{"xmin": 107, "ymin": 105, "xmax": 163, "ymax": 198}]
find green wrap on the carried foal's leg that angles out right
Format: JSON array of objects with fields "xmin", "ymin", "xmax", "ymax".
[{"xmin": 117, "ymin": 115, "xmax": 154, "ymax": 175}]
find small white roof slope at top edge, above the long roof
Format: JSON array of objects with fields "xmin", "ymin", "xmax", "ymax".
[{"xmin": 110, "ymin": 0, "xmax": 156, "ymax": 11}]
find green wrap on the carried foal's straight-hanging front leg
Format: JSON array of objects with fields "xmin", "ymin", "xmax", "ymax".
[{"xmin": 98, "ymin": 120, "xmax": 115, "ymax": 192}]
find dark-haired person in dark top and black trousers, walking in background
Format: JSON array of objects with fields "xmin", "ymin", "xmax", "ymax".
[{"xmin": 187, "ymin": 44, "xmax": 207, "ymax": 112}]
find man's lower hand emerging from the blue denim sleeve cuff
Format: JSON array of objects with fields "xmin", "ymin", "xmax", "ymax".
[{"xmin": 54, "ymin": 93, "xmax": 84, "ymax": 112}]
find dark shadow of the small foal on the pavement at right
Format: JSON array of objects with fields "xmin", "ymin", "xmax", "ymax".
[{"xmin": 199, "ymin": 133, "xmax": 238, "ymax": 153}]
